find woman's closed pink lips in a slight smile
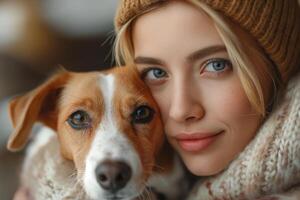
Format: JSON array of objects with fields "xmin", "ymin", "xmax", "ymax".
[{"xmin": 176, "ymin": 131, "xmax": 223, "ymax": 152}]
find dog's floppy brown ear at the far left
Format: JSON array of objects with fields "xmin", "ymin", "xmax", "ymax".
[{"xmin": 7, "ymin": 72, "xmax": 71, "ymax": 151}]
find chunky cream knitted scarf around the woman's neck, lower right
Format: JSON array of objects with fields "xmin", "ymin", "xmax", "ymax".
[{"xmin": 188, "ymin": 74, "xmax": 300, "ymax": 200}]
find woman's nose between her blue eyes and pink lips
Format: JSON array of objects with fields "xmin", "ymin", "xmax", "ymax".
[{"xmin": 169, "ymin": 82, "xmax": 205, "ymax": 122}]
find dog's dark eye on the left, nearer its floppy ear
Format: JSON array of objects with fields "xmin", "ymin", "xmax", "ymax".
[{"xmin": 67, "ymin": 110, "xmax": 91, "ymax": 130}]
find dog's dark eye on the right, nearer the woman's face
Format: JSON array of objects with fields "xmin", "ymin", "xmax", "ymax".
[{"xmin": 131, "ymin": 106, "xmax": 154, "ymax": 124}]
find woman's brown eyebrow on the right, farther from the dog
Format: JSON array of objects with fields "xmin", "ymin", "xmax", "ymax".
[{"xmin": 187, "ymin": 45, "xmax": 226, "ymax": 62}]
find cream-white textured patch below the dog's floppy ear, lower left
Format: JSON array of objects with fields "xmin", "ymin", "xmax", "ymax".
[{"xmin": 21, "ymin": 127, "xmax": 89, "ymax": 200}]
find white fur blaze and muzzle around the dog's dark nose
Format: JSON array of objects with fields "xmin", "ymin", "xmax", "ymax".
[{"xmin": 83, "ymin": 75, "xmax": 142, "ymax": 199}]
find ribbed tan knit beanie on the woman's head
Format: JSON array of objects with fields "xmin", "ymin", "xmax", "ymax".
[{"xmin": 115, "ymin": 0, "xmax": 300, "ymax": 80}]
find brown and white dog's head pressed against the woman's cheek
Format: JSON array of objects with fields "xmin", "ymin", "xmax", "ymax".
[{"xmin": 8, "ymin": 67, "xmax": 185, "ymax": 200}]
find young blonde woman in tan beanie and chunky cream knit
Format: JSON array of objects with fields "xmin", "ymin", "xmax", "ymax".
[{"xmin": 115, "ymin": 0, "xmax": 300, "ymax": 200}]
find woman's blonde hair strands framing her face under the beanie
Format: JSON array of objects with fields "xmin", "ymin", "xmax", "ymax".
[{"xmin": 114, "ymin": 0, "xmax": 280, "ymax": 116}]
